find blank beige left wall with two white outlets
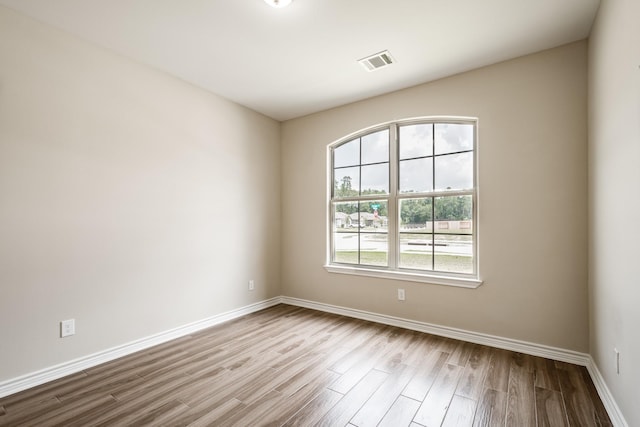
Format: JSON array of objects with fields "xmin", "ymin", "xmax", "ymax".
[{"xmin": 0, "ymin": 7, "xmax": 280, "ymax": 382}]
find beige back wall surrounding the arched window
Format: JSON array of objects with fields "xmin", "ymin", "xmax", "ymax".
[{"xmin": 281, "ymin": 42, "xmax": 588, "ymax": 351}]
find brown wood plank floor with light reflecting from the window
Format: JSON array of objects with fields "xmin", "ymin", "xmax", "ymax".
[{"xmin": 0, "ymin": 305, "xmax": 611, "ymax": 427}]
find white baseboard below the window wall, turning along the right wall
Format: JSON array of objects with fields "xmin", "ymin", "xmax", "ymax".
[{"xmin": 281, "ymin": 297, "xmax": 629, "ymax": 427}]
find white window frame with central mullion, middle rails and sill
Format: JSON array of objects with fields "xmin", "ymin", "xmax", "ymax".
[{"xmin": 324, "ymin": 116, "xmax": 483, "ymax": 288}]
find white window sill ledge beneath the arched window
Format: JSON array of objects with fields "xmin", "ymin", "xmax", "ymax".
[{"xmin": 324, "ymin": 264, "xmax": 483, "ymax": 289}]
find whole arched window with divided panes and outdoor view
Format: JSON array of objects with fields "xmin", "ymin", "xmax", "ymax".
[{"xmin": 327, "ymin": 118, "xmax": 481, "ymax": 287}]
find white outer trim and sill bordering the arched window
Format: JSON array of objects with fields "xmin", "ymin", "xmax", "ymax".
[{"xmin": 324, "ymin": 116, "xmax": 484, "ymax": 289}]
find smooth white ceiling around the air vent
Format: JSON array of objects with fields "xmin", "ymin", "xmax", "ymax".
[{"xmin": 0, "ymin": 0, "xmax": 599, "ymax": 120}]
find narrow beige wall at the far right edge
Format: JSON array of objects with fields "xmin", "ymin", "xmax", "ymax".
[{"xmin": 589, "ymin": 0, "xmax": 640, "ymax": 426}]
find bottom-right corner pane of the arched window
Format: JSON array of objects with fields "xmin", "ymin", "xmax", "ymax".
[{"xmin": 434, "ymin": 234, "xmax": 473, "ymax": 273}]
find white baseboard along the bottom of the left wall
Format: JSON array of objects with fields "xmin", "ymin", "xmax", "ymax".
[{"xmin": 0, "ymin": 297, "xmax": 281, "ymax": 397}]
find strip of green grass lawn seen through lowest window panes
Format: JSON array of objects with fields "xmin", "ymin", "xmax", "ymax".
[{"xmin": 334, "ymin": 251, "xmax": 473, "ymax": 273}]
